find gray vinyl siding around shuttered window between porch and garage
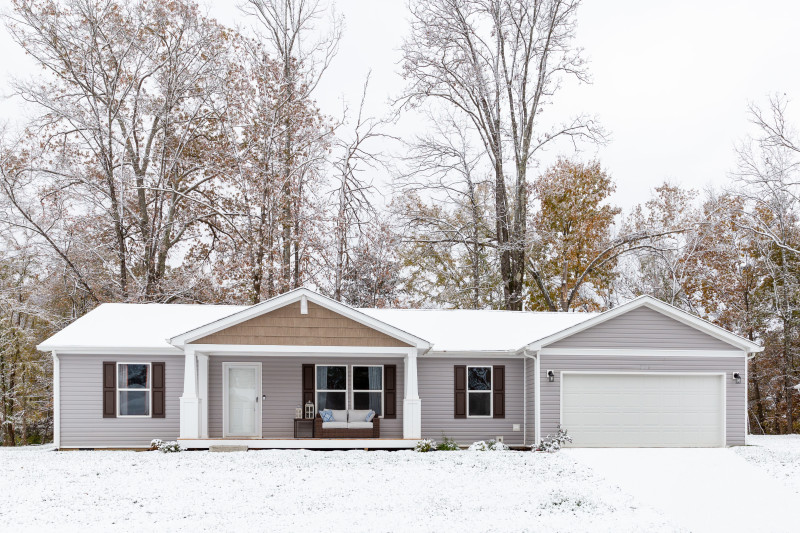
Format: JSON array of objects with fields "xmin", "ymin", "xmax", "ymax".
[{"xmin": 417, "ymin": 357, "xmax": 532, "ymax": 446}]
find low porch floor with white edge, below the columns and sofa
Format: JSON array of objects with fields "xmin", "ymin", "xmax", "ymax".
[{"xmin": 178, "ymin": 438, "xmax": 419, "ymax": 450}]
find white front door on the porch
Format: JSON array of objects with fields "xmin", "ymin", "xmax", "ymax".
[{"xmin": 222, "ymin": 363, "xmax": 261, "ymax": 437}]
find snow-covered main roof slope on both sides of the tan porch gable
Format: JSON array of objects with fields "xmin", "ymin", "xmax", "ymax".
[{"xmin": 39, "ymin": 303, "xmax": 597, "ymax": 353}]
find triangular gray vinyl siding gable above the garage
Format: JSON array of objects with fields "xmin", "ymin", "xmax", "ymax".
[{"xmin": 547, "ymin": 307, "xmax": 736, "ymax": 350}]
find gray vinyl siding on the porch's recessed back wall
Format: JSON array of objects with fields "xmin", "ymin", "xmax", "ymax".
[{"xmin": 208, "ymin": 355, "xmax": 404, "ymax": 439}]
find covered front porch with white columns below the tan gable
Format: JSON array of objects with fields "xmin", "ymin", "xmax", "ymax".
[{"xmin": 180, "ymin": 345, "xmax": 421, "ymax": 438}]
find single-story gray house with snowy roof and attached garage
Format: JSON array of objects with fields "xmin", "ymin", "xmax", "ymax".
[{"xmin": 39, "ymin": 289, "xmax": 762, "ymax": 449}]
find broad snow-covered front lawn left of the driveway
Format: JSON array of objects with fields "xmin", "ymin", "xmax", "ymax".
[{"xmin": 0, "ymin": 448, "xmax": 680, "ymax": 532}]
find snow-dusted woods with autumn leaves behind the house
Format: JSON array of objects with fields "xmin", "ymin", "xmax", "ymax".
[{"xmin": 0, "ymin": 0, "xmax": 800, "ymax": 445}]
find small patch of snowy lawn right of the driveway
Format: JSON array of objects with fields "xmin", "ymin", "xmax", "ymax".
[{"xmin": 735, "ymin": 435, "xmax": 800, "ymax": 492}]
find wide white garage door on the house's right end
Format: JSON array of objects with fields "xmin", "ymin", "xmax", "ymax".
[{"xmin": 561, "ymin": 372, "xmax": 725, "ymax": 447}]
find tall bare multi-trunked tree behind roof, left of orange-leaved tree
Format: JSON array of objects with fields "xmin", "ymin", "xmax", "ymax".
[{"xmin": 398, "ymin": 0, "xmax": 602, "ymax": 310}]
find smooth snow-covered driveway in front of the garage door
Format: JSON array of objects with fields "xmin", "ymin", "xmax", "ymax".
[{"xmin": 566, "ymin": 448, "xmax": 800, "ymax": 533}]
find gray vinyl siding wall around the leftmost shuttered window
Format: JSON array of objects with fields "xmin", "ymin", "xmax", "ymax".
[{"xmin": 58, "ymin": 354, "xmax": 184, "ymax": 448}]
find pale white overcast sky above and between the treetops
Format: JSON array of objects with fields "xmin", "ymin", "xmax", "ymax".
[{"xmin": 0, "ymin": 0, "xmax": 800, "ymax": 208}]
